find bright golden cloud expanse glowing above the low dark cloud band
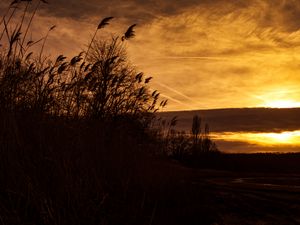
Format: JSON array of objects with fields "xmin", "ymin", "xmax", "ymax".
[{"xmin": 126, "ymin": 1, "xmax": 300, "ymax": 110}]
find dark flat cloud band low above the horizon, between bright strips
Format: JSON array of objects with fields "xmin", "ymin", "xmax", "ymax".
[{"xmin": 160, "ymin": 108, "xmax": 300, "ymax": 132}]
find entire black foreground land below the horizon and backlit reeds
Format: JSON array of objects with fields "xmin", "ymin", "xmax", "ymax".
[{"xmin": 0, "ymin": 116, "xmax": 300, "ymax": 225}]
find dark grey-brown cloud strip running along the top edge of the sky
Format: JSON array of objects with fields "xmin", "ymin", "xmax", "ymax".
[{"xmin": 0, "ymin": 0, "xmax": 300, "ymax": 32}]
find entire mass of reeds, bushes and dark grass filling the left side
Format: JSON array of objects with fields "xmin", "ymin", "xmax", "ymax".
[{"xmin": 0, "ymin": 0, "xmax": 220, "ymax": 224}]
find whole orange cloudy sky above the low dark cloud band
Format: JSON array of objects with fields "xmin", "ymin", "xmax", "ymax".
[{"xmin": 0, "ymin": 0, "xmax": 300, "ymax": 111}]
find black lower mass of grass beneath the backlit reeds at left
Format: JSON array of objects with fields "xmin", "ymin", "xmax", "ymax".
[{"xmin": 0, "ymin": 111, "xmax": 223, "ymax": 224}]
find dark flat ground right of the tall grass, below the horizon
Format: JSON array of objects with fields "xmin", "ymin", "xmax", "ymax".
[{"xmin": 154, "ymin": 159, "xmax": 300, "ymax": 225}]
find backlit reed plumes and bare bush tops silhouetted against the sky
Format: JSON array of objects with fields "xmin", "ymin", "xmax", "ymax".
[{"xmin": 0, "ymin": 1, "xmax": 166, "ymax": 119}]
